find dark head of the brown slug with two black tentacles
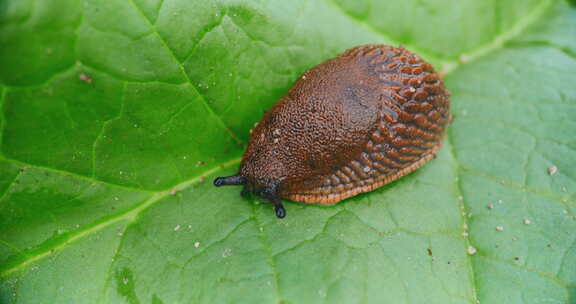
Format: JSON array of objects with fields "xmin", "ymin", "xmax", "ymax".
[{"xmin": 214, "ymin": 174, "xmax": 286, "ymax": 218}]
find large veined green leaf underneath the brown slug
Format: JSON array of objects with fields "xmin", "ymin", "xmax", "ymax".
[{"xmin": 0, "ymin": 0, "xmax": 576, "ymax": 304}]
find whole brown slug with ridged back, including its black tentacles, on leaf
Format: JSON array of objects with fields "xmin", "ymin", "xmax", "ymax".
[{"xmin": 214, "ymin": 45, "xmax": 451, "ymax": 218}]
